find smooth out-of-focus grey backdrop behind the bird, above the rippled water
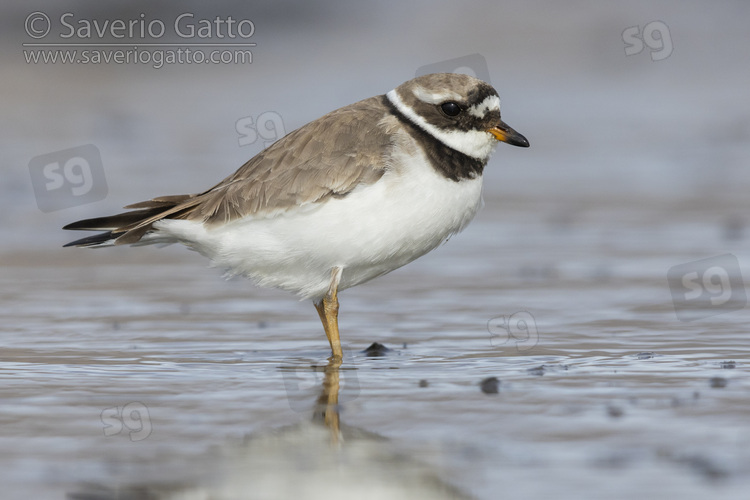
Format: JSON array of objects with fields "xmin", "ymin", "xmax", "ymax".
[{"xmin": 0, "ymin": 1, "xmax": 750, "ymax": 249}]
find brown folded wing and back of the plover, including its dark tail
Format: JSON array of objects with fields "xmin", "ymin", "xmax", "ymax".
[{"xmin": 64, "ymin": 96, "xmax": 391, "ymax": 246}]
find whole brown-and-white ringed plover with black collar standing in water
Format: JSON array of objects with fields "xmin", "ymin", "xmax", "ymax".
[{"xmin": 63, "ymin": 73, "xmax": 529, "ymax": 360}]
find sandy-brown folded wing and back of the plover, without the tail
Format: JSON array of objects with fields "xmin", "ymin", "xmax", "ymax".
[{"xmin": 187, "ymin": 94, "xmax": 390, "ymax": 223}]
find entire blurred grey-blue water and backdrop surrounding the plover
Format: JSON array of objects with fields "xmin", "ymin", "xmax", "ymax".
[{"xmin": 0, "ymin": 0, "xmax": 750, "ymax": 498}]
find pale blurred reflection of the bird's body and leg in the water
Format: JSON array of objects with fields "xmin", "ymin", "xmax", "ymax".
[{"xmin": 68, "ymin": 353, "xmax": 473, "ymax": 500}]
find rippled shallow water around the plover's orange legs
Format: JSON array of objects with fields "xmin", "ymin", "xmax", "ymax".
[{"xmin": 0, "ymin": 199, "xmax": 750, "ymax": 498}]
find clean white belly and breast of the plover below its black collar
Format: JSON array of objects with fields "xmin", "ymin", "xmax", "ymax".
[{"xmin": 155, "ymin": 148, "xmax": 482, "ymax": 298}]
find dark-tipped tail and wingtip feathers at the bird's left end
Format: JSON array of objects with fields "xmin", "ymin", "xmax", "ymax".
[{"xmin": 63, "ymin": 194, "xmax": 199, "ymax": 247}]
